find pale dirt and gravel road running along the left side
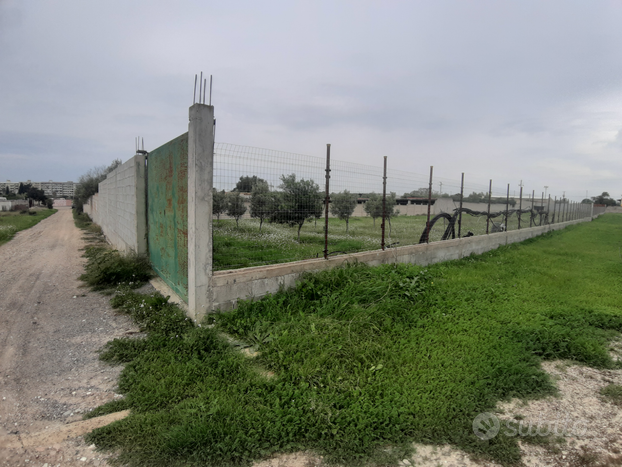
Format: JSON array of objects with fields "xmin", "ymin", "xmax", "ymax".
[{"xmin": 0, "ymin": 208, "xmax": 135, "ymax": 467}]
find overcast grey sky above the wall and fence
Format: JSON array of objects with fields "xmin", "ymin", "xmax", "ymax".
[{"xmin": 0, "ymin": 0, "xmax": 622, "ymax": 201}]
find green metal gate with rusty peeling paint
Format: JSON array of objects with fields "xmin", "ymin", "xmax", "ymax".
[{"xmin": 147, "ymin": 133, "xmax": 188, "ymax": 303}]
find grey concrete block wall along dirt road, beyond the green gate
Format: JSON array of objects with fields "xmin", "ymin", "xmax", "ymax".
[{"xmin": 84, "ymin": 155, "xmax": 147, "ymax": 254}]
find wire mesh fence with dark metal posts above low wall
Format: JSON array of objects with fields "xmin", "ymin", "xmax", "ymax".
[{"xmin": 213, "ymin": 143, "xmax": 592, "ymax": 270}]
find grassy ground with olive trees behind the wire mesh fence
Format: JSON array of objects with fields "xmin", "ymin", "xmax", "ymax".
[{"xmin": 213, "ymin": 214, "xmax": 572, "ymax": 271}]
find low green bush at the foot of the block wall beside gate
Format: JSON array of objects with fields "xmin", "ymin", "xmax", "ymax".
[{"xmin": 80, "ymin": 247, "xmax": 153, "ymax": 290}]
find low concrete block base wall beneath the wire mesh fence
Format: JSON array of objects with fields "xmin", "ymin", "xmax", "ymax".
[{"xmin": 212, "ymin": 217, "xmax": 591, "ymax": 311}]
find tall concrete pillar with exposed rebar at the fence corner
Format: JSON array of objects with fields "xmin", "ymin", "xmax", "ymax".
[{"xmin": 188, "ymin": 104, "xmax": 214, "ymax": 320}]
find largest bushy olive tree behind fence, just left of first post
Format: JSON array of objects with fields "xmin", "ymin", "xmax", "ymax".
[{"xmin": 270, "ymin": 174, "xmax": 322, "ymax": 242}]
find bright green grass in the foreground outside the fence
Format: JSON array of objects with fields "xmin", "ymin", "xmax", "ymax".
[{"xmin": 87, "ymin": 215, "xmax": 622, "ymax": 466}]
